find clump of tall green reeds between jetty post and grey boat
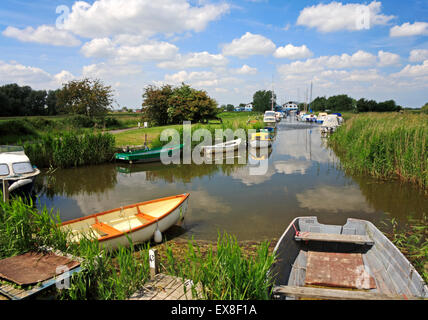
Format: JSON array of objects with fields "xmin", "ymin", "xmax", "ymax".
[{"xmin": 165, "ymin": 234, "xmax": 274, "ymax": 300}]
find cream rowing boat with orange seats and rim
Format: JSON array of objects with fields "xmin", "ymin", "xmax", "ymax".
[{"xmin": 61, "ymin": 193, "xmax": 190, "ymax": 249}]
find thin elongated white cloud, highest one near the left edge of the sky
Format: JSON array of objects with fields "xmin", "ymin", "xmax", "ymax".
[{"xmin": 3, "ymin": 25, "xmax": 80, "ymax": 47}]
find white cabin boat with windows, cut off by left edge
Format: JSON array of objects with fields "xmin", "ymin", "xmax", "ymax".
[{"xmin": 0, "ymin": 146, "xmax": 40, "ymax": 194}]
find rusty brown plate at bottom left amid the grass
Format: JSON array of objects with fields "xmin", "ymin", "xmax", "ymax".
[{"xmin": 0, "ymin": 251, "xmax": 80, "ymax": 285}]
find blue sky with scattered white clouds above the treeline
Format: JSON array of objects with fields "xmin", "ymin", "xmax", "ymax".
[{"xmin": 0, "ymin": 0, "xmax": 428, "ymax": 109}]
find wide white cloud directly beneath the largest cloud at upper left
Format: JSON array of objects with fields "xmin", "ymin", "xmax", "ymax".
[{"xmin": 81, "ymin": 38, "xmax": 178, "ymax": 63}]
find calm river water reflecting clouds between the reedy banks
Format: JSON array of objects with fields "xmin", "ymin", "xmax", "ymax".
[{"xmin": 36, "ymin": 117, "xmax": 428, "ymax": 240}]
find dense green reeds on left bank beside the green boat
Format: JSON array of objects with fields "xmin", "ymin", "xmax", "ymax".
[{"xmin": 23, "ymin": 133, "xmax": 115, "ymax": 168}]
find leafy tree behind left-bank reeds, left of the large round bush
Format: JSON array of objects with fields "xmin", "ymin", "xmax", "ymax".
[{"xmin": 56, "ymin": 78, "xmax": 113, "ymax": 117}]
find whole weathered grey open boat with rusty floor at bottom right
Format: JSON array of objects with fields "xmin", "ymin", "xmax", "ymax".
[{"xmin": 271, "ymin": 217, "xmax": 428, "ymax": 300}]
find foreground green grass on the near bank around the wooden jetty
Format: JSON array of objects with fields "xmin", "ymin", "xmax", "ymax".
[{"xmin": 0, "ymin": 192, "xmax": 273, "ymax": 300}]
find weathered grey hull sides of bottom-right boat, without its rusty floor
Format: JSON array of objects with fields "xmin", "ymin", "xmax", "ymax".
[{"xmin": 270, "ymin": 217, "xmax": 428, "ymax": 299}]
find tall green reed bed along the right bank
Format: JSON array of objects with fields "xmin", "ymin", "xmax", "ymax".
[{"xmin": 329, "ymin": 113, "xmax": 428, "ymax": 190}]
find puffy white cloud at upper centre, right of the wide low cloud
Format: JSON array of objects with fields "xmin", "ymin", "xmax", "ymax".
[{"xmin": 223, "ymin": 32, "xmax": 276, "ymax": 58}]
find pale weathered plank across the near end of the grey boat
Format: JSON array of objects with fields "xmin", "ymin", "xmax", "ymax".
[{"xmin": 273, "ymin": 286, "xmax": 419, "ymax": 300}]
